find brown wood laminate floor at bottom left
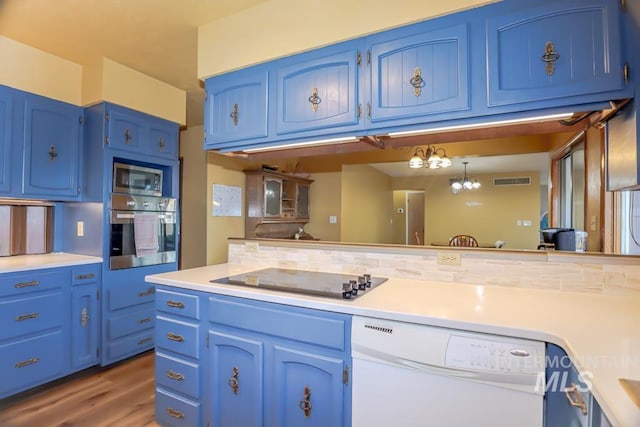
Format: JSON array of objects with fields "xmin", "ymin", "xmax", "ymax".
[{"xmin": 0, "ymin": 352, "xmax": 160, "ymax": 427}]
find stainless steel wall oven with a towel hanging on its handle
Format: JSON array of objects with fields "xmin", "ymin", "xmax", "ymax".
[{"xmin": 109, "ymin": 194, "xmax": 176, "ymax": 270}]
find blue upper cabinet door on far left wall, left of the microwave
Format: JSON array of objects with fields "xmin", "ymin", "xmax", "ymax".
[{"xmin": 22, "ymin": 94, "xmax": 83, "ymax": 200}]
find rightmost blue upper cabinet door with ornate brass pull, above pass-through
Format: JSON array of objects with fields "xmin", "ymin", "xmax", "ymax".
[{"xmin": 487, "ymin": 0, "xmax": 625, "ymax": 110}]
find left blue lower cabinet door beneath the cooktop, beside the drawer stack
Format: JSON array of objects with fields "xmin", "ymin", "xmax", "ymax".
[{"xmin": 209, "ymin": 330, "xmax": 264, "ymax": 427}]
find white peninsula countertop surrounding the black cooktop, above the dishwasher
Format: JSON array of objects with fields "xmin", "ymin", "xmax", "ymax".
[{"xmin": 146, "ymin": 264, "xmax": 640, "ymax": 427}]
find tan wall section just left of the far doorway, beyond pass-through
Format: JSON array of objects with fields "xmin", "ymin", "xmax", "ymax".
[{"xmin": 340, "ymin": 165, "xmax": 393, "ymax": 243}]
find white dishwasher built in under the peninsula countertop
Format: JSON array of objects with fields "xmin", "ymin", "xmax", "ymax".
[{"xmin": 351, "ymin": 316, "xmax": 545, "ymax": 427}]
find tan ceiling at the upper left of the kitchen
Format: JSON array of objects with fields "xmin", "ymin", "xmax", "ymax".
[{"xmin": 0, "ymin": 0, "xmax": 266, "ymax": 126}]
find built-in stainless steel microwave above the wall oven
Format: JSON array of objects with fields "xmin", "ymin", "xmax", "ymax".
[{"xmin": 113, "ymin": 162, "xmax": 162, "ymax": 196}]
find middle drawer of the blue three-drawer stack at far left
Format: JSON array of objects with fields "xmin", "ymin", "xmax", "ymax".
[{"xmin": 0, "ymin": 292, "xmax": 69, "ymax": 341}]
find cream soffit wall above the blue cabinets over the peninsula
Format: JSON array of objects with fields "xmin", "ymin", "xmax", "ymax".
[{"xmin": 198, "ymin": 0, "xmax": 494, "ymax": 79}]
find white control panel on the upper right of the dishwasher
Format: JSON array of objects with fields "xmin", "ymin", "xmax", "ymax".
[{"xmin": 445, "ymin": 335, "xmax": 545, "ymax": 374}]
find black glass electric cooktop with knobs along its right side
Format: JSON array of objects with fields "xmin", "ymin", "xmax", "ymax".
[{"xmin": 211, "ymin": 268, "xmax": 387, "ymax": 299}]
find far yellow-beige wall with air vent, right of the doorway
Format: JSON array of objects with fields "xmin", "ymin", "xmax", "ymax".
[{"xmin": 393, "ymin": 172, "xmax": 540, "ymax": 249}]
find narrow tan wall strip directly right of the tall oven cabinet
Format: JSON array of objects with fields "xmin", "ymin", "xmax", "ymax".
[{"xmin": 180, "ymin": 126, "xmax": 208, "ymax": 269}]
